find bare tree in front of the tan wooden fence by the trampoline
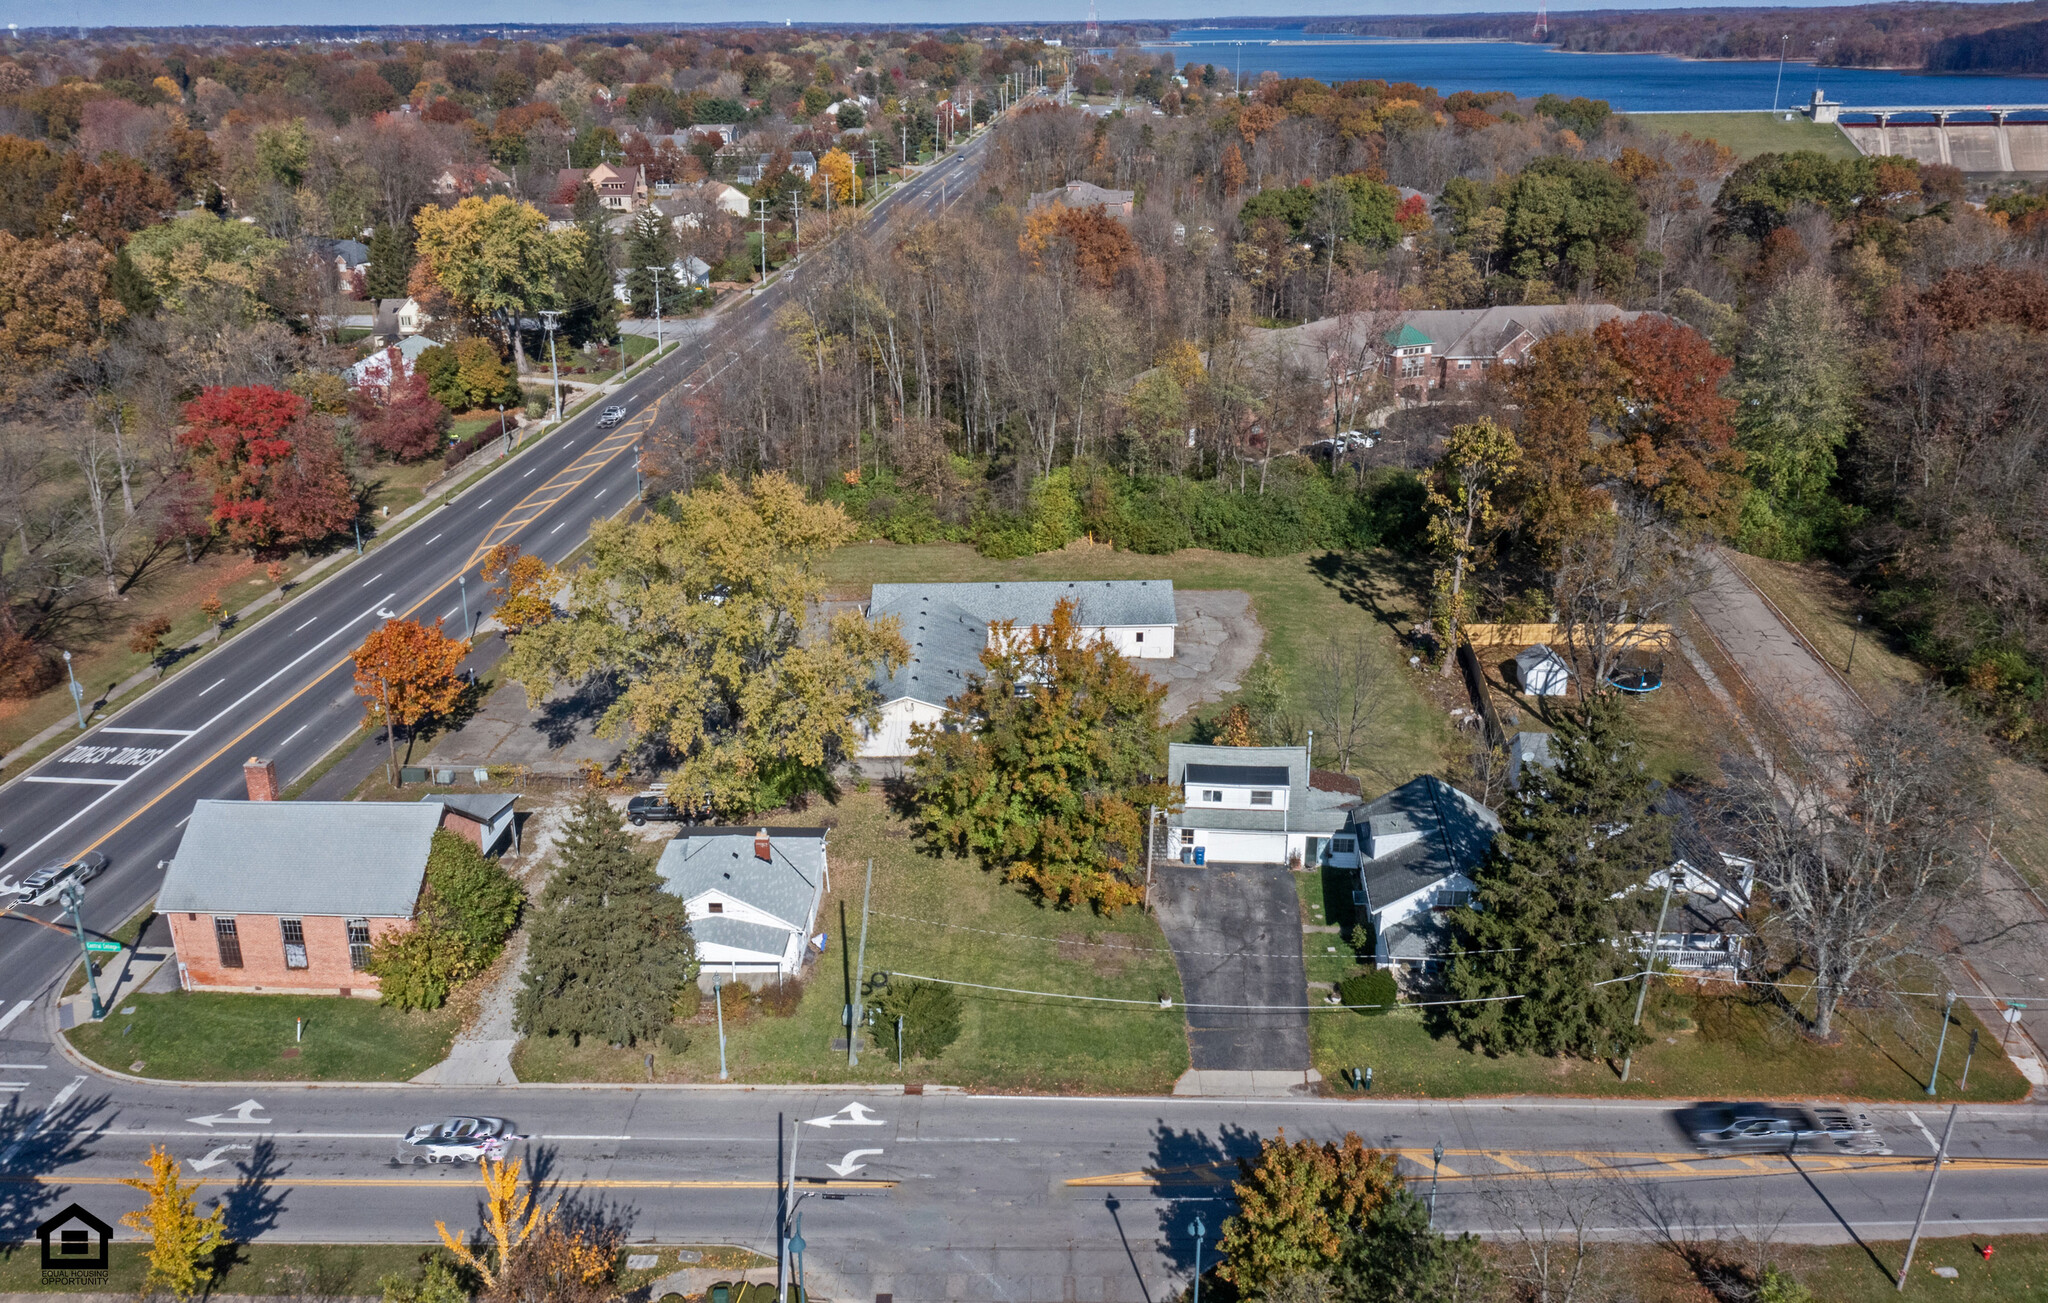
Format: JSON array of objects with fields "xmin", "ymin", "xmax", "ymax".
[{"xmin": 1550, "ymin": 500, "xmax": 1708, "ymax": 684}]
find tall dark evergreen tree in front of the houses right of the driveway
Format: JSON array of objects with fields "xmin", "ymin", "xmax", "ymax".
[{"xmin": 1446, "ymin": 692, "xmax": 1671, "ymax": 1057}]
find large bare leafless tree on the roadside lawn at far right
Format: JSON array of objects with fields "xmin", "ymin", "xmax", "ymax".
[{"xmin": 1733, "ymin": 690, "xmax": 1987, "ymax": 1041}]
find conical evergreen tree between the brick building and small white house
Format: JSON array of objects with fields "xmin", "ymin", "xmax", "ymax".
[{"xmin": 518, "ymin": 793, "xmax": 696, "ymax": 1045}]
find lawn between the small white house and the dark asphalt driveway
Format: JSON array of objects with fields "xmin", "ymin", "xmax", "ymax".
[{"xmin": 512, "ymin": 791, "xmax": 1188, "ymax": 1094}]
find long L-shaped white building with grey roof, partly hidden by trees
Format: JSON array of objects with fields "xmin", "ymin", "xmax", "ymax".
[{"xmin": 860, "ymin": 580, "xmax": 1180, "ymax": 758}]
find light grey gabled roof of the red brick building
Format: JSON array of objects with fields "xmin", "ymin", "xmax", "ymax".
[{"xmin": 156, "ymin": 801, "xmax": 440, "ymax": 918}]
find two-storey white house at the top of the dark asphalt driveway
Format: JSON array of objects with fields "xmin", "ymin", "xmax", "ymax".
[{"xmin": 1165, "ymin": 742, "xmax": 1358, "ymax": 867}]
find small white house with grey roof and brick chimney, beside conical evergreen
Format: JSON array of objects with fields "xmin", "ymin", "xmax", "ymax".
[{"xmin": 655, "ymin": 828, "xmax": 831, "ymax": 985}]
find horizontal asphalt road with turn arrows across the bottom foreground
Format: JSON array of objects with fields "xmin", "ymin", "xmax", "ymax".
[{"xmin": 0, "ymin": 1065, "xmax": 2048, "ymax": 1301}]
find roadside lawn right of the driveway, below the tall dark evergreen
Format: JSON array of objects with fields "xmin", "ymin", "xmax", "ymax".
[{"xmin": 1309, "ymin": 967, "xmax": 2028, "ymax": 1102}]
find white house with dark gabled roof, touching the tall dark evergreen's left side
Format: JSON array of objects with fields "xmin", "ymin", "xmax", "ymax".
[{"xmin": 1346, "ymin": 774, "xmax": 1501, "ymax": 969}]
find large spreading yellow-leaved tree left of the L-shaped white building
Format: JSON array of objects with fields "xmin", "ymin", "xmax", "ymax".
[{"xmin": 506, "ymin": 473, "xmax": 909, "ymax": 817}]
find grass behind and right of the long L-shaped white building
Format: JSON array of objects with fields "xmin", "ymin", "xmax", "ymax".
[{"xmin": 819, "ymin": 543, "xmax": 1464, "ymax": 797}]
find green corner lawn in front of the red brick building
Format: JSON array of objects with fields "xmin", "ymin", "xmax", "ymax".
[{"xmin": 66, "ymin": 992, "xmax": 457, "ymax": 1082}]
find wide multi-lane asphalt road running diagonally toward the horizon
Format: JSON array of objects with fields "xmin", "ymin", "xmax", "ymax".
[{"xmin": 0, "ymin": 135, "xmax": 987, "ymax": 1032}]
